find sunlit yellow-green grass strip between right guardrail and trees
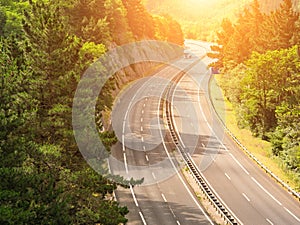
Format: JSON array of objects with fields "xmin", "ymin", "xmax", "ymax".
[{"xmin": 211, "ymin": 75, "xmax": 299, "ymax": 190}]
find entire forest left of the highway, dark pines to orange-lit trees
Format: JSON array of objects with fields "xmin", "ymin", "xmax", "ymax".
[{"xmin": 0, "ymin": 0, "xmax": 183, "ymax": 225}]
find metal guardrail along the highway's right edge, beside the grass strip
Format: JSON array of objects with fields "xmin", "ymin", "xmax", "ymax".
[{"xmin": 209, "ymin": 75, "xmax": 300, "ymax": 201}]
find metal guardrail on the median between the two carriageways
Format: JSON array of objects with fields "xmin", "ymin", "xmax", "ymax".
[{"xmin": 163, "ymin": 61, "xmax": 238, "ymax": 225}]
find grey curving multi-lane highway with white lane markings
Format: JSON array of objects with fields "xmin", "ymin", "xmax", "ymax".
[{"xmin": 109, "ymin": 41, "xmax": 300, "ymax": 225}]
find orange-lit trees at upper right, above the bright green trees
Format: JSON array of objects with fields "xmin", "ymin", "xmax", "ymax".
[{"xmin": 209, "ymin": 0, "xmax": 299, "ymax": 71}]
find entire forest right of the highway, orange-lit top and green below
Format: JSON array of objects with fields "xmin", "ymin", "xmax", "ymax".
[{"xmin": 209, "ymin": 0, "xmax": 300, "ymax": 191}]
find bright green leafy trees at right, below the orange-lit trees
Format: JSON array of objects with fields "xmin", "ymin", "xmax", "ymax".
[{"xmin": 221, "ymin": 37, "xmax": 300, "ymax": 183}]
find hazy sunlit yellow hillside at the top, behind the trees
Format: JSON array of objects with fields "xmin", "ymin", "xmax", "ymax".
[{"xmin": 143, "ymin": 0, "xmax": 300, "ymax": 41}]
